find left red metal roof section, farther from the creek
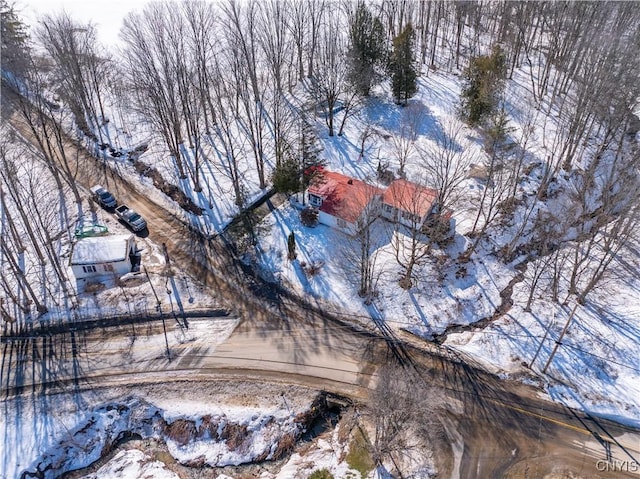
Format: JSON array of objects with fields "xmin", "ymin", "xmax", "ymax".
[{"xmin": 308, "ymin": 170, "xmax": 384, "ymax": 223}]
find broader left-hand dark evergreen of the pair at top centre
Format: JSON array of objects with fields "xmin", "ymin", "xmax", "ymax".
[{"xmin": 347, "ymin": 2, "xmax": 387, "ymax": 96}]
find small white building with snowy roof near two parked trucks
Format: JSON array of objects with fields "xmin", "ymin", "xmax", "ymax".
[{"xmin": 71, "ymin": 234, "xmax": 137, "ymax": 280}]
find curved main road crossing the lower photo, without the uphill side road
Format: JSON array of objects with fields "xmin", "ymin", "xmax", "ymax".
[{"xmin": 2, "ymin": 317, "xmax": 640, "ymax": 478}]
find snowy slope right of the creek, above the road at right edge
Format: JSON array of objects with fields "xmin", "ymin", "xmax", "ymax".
[{"xmin": 446, "ymin": 281, "xmax": 640, "ymax": 427}]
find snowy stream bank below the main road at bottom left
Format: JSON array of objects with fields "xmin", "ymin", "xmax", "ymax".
[{"xmin": 0, "ymin": 382, "xmax": 357, "ymax": 479}]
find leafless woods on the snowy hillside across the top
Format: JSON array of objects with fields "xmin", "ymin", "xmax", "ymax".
[{"xmin": 0, "ymin": 0, "xmax": 640, "ymax": 321}]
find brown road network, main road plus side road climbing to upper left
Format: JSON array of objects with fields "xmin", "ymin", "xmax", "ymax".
[{"xmin": 1, "ymin": 84, "xmax": 640, "ymax": 477}]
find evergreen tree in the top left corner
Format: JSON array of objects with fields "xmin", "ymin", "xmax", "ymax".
[{"xmin": 0, "ymin": 0, "xmax": 29, "ymax": 78}]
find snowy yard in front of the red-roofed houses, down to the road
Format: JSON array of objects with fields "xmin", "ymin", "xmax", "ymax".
[{"xmin": 256, "ymin": 201, "xmax": 509, "ymax": 337}]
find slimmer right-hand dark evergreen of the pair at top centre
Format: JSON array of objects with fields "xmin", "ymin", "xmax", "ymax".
[{"xmin": 389, "ymin": 23, "xmax": 418, "ymax": 105}]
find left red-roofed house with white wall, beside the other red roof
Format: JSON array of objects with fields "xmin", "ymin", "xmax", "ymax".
[{"xmin": 307, "ymin": 170, "xmax": 384, "ymax": 234}]
